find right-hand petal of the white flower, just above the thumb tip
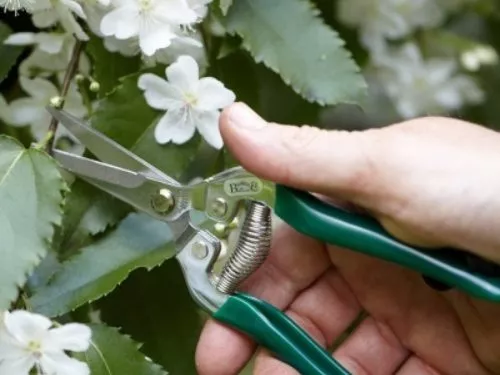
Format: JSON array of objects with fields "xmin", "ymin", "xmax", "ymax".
[{"xmin": 196, "ymin": 77, "xmax": 236, "ymax": 111}]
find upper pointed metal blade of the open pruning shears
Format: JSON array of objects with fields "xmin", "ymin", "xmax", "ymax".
[{"xmin": 47, "ymin": 107, "xmax": 181, "ymax": 186}]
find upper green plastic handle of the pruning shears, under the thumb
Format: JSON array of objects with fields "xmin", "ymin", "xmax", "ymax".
[{"xmin": 275, "ymin": 185, "xmax": 500, "ymax": 302}]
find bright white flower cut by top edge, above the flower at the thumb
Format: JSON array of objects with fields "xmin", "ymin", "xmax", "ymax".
[{"xmin": 101, "ymin": 0, "xmax": 198, "ymax": 56}]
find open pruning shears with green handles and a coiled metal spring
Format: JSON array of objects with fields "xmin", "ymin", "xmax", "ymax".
[{"xmin": 48, "ymin": 108, "xmax": 500, "ymax": 375}]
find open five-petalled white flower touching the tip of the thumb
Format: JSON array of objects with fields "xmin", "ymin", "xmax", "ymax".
[{"xmin": 138, "ymin": 56, "xmax": 235, "ymax": 149}]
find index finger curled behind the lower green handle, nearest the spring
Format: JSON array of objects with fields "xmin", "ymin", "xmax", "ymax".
[{"xmin": 196, "ymin": 226, "xmax": 330, "ymax": 375}]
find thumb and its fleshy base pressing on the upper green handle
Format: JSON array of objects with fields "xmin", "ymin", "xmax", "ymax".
[{"xmin": 220, "ymin": 103, "xmax": 500, "ymax": 263}]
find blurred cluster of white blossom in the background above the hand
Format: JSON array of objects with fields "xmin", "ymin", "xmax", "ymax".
[{"xmin": 338, "ymin": 0, "xmax": 497, "ymax": 118}]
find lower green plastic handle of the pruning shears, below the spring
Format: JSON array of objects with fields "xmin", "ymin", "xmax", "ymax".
[{"xmin": 214, "ymin": 293, "xmax": 350, "ymax": 375}]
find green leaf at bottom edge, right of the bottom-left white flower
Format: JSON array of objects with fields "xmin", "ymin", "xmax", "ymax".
[{"xmin": 73, "ymin": 324, "xmax": 167, "ymax": 375}]
